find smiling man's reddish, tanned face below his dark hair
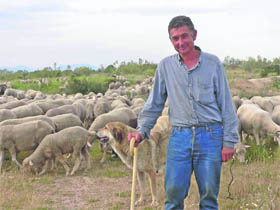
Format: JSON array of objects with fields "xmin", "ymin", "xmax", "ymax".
[{"xmin": 170, "ymin": 26, "xmax": 197, "ymax": 56}]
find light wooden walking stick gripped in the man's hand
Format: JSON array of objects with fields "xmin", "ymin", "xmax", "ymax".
[{"xmin": 129, "ymin": 137, "xmax": 138, "ymax": 210}]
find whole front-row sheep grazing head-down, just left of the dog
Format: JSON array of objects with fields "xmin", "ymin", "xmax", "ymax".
[{"xmin": 23, "ymin": 126, "xmax": 96, "ymax": 176}]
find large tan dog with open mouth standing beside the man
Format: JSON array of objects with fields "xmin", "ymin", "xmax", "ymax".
[{"xmin": 97, "ymin": 116, "xmax": 171, "ymax": 205}]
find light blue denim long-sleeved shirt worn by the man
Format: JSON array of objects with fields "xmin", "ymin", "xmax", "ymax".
[{"xmin": 137, "ymin": 47, "xmax": 239, "ymax": 147}]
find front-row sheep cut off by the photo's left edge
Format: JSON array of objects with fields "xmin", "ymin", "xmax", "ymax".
[{"xmin": 0, "ymin": 120, "xmax": 54, "ymax": 173}]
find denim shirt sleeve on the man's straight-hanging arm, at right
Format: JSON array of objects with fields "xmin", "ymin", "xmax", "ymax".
[{"xmin": 216, "ymin": 62, "xmax": 240, "ymax": 147}]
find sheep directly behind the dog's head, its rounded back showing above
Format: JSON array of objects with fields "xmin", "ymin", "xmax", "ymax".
[{"xmin": 89, "ymin": 108, "xmax": 137, "ymax": 163}]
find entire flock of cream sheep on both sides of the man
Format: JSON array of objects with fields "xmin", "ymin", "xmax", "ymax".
[{"xmin": 0, "ymin": 77, "xmax": 280, "ymax": 175}]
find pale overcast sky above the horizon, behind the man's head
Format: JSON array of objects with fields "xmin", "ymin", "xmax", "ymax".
[{"xmin": 0, "ymin": 0, "xmax": 280, "ymax": 68}]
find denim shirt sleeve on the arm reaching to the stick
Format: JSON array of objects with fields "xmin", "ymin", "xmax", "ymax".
[{"xmin": 137, "ymin": 63, "xmax": 167, "ymax": 139}]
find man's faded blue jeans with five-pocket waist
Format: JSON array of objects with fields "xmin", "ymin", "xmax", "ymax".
[{"xmin": 165, "ymin": 123, "xmax": 223, "ymax": 210}]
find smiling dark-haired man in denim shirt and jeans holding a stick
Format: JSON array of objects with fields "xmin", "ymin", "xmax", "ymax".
[{"xmin": 128, "ymin": 16, "xmax": 239, "ymax": 210}]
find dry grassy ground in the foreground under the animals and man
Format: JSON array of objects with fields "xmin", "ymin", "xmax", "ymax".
[{"xmin": 0, "ymin": 139, "xmax": 280, "ymax": 210}]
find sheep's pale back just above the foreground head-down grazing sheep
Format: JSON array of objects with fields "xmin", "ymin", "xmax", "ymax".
[{"xmin": 50, "ymin": 113, "xmax": 82, "ymax": 132}]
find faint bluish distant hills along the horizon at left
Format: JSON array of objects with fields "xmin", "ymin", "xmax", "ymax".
[{"xmin": 0, "ymin": 64, "xmax": 99, "ymax": 72}]
